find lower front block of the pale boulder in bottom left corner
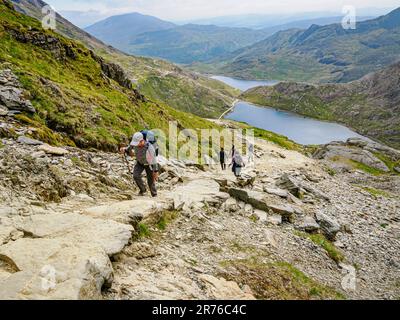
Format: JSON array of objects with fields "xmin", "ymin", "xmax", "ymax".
[{"xmin": 0, "ymin": 238, "xmax": 113, "ymax": 300}]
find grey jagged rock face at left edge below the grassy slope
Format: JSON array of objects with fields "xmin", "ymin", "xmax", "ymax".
[{"xmin": 0, "ymin": 69, "xmax": 36, "ymax": 116}]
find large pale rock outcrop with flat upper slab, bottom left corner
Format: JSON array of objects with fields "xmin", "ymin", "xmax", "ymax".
[{"xmin": 0, "ymin": 213, "xmax": 133, "ymax": 299}]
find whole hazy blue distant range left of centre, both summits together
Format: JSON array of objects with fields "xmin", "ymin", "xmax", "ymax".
[{"xmin": 85, "ymin": 13, "xmax": 269, "ymax": 64}]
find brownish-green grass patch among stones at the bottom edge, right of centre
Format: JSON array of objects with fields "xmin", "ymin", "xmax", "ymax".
[{"xmin": 220, "ymin": 257, "xmax": 345, "ymax": 300}]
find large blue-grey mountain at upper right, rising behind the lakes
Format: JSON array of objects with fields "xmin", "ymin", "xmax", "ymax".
[{"xmin": 202, "ymin": 8, "xmax": 400, "ymax": 82}]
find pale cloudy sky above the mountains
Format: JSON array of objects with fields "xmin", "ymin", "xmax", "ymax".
[{"xmin": 47, "ymin": 0, "xmax": 399, "ymax": 20}]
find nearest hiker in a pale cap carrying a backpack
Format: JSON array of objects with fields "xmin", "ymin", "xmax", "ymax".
[{"xmin": 120, "ymin": 132, "xmax": 159, "ymax": 197}]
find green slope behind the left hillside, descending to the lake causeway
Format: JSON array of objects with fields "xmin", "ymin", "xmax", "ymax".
[{"xmin": 102, "ymin": 53, "xmax": 240, "ymax": 118}]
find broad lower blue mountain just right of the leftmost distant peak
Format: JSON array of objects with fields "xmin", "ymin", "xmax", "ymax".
[{"xmin": 114, "ymin": 24, "xmax": 269, "ymax": 64}]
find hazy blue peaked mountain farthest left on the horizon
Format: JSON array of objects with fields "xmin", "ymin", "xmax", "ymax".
[{"xmin": 85, "ymin": 12, "xmax": 175, "ymax": 49}]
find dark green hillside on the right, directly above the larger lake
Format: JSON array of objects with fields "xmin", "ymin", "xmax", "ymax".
[{"xmin": 242, "ymin": 63, "xmax": 400, "ymax": 148}]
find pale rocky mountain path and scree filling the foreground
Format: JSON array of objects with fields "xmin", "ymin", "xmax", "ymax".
[{"xmin": 0, "ymin": 120, "xmax": 400, "ymax": 299}]
